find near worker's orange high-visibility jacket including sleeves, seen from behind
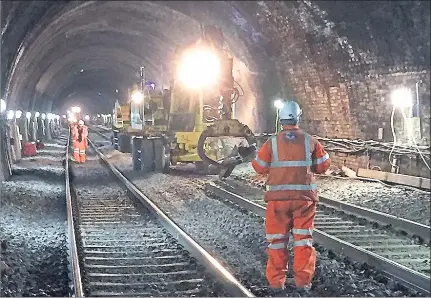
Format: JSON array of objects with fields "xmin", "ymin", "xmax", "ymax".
[{"xmin": 252, "ymin": 125, "xmax": 331, "ymax": 201}]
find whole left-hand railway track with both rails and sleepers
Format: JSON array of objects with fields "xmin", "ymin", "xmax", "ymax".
[{"xmin": 66, "ymin": 132, "xmax": 253, "ymax": 297}]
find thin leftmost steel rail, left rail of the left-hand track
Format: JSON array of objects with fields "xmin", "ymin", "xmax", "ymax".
[{"xmin": 65, "ymin": 128, "xmax": 84, "ymax": 297}]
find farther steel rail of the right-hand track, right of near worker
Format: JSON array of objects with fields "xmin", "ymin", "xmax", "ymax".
[{"xmin": 319, "ymin": 196, "xmax": 431, "ymax": 242}]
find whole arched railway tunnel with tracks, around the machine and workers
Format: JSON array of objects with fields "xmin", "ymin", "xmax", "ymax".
[{"xmin": 0, "ymin": 1, "xmax": 431, "ymax": 297}]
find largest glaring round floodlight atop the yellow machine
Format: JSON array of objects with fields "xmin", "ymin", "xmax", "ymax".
[{"xmin": 178, "ymin": 48, "xmax": 220, "ymax": 89}]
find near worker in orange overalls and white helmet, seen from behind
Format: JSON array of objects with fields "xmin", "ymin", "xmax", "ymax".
[{"xmin": 252, "ymin": 101, "xmax": 331, "ymax": 294}]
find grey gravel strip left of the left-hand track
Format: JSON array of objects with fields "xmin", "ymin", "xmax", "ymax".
[{"xmin": 0, "ymin": 135, "xmax": 69, "ymax": 297}]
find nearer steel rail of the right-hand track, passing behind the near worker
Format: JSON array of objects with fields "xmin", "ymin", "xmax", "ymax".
[{"xmin": 205, "ymin": 182, "xmax": 431, "ymax": 296}]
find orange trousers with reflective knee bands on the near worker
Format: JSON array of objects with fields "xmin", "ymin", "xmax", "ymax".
[{"xmin": 265, "ymin": 200, "xmax": 316, "ymax": 289}]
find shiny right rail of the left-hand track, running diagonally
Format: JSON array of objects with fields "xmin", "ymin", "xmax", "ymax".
[{"xmin": 88, "ymin": 139, "xmax": 255, "ymax": 297}]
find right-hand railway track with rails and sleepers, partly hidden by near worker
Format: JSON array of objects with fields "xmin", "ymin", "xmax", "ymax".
[{"xmin": 205, "ymin": 181, "xmax": 431, "ymax": 296}]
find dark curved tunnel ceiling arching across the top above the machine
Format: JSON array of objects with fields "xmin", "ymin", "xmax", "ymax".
[{"xmin": 1, "ymin": 1, "xmax": 430, "ymax": 128}]
